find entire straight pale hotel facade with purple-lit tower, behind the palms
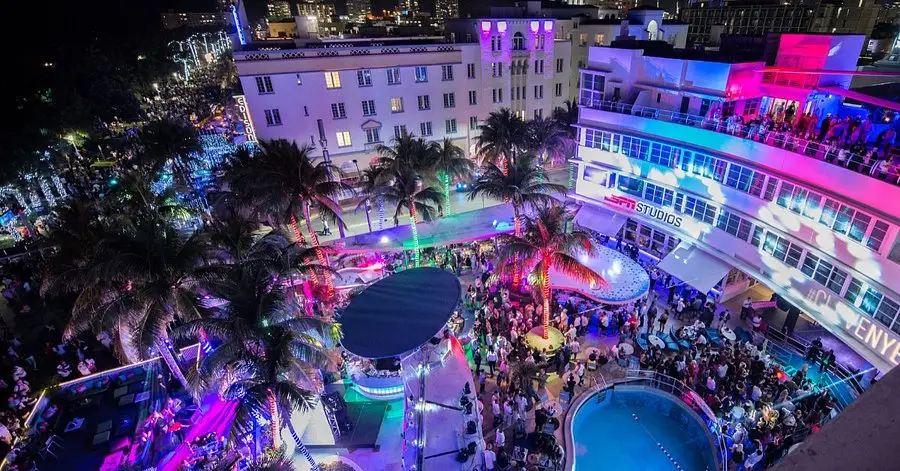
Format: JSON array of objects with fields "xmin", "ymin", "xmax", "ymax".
[{"xmin": 234, "ymin": 18, "xmax": 571, "ymax": 175}]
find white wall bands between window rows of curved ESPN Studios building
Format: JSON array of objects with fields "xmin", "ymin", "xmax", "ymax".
[{"xmin": 575, "ymin": 143, "xmax": 900, "ymax": 370}]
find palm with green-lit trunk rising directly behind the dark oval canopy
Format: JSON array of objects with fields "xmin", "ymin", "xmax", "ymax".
[{"xmin": 375, "ymin": 166, "xmax": 441, "ymax": 267}]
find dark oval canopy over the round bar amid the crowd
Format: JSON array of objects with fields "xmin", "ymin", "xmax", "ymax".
[{"xmin": 340, "ymin": 267, "xmax": 462, "ymax": 358}]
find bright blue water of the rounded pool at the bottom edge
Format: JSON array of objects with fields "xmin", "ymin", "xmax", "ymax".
[{"xmin": 572, "ymin": 386, "xmax": 717, "ymax": 471}]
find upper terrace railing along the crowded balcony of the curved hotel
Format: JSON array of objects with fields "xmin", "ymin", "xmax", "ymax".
[{"xmin": 581, "ymin": 100, "xmax": 900, "ymax": 185}]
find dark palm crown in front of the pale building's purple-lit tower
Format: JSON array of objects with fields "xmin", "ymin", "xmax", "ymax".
[{"xmin": 475, "ymin": 108, "xmax": 528, "ymax": 169}]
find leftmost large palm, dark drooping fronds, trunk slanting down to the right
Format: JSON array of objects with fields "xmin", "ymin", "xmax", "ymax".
[{"xmin": 44, "ymin": 220, "xmax": 209, "ymax": 388}]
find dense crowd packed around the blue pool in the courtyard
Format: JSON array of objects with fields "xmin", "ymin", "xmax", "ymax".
[{"xmin": 426, "ymin": 234, "xmax": 837, "ymax": 470}]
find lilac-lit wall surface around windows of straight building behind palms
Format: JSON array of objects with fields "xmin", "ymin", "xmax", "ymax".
[{"xmin": 235, "ymin": 28, "xmax": 572, "ymax": 173}]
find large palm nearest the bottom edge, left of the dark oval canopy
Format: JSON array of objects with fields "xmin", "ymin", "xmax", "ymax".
[{"xmin": 175, "ymin": 264, "xmax": 334, "ymax": 469}]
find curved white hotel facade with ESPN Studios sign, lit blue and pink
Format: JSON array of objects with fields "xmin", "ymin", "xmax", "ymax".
[{"xmin": 571, "ymin": 35, "xmax": 900, "ymax": 372}]
